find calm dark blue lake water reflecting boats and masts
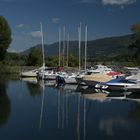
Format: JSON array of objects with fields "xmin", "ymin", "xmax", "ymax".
[{"xmin": 0, "ymin": 78, "xmax": 140, "ymax": 140}]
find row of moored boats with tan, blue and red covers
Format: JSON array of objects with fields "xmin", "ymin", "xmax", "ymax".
[{"xmin": 20, "ymin": 65, "xmax": 140, "ymax": 91}]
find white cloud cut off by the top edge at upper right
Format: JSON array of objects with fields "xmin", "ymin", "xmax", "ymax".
[{"xmin": 102, "ymin": 0, "xmax": 137, "ymax": 5}]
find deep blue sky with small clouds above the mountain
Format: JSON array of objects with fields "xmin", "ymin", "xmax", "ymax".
[{"xmin": 0, "ymin": 0, "xmax": 140, "ymax": 51}]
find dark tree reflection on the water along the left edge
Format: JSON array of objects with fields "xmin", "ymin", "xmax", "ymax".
[{"xmin": 0, "ymin": 78, "xmax": 11, "ymax": 125}]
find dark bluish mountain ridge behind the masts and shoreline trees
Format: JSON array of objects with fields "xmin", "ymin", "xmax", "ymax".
[{"xmin": 20, "ymin": 34, "xmax": 132, "ymax": 58}]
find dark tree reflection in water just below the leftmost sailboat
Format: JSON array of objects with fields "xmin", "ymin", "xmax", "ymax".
[{"xmin": 27, "ymin": 82, "xmax": 42, "ymax": 97}]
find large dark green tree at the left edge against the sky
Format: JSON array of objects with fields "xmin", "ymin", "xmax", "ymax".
[{"xmin": 0, "ymin": 16, "xmax": 12, "ymax": 60}]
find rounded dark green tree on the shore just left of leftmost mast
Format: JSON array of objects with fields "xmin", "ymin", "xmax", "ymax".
[{"xmin": 26, "ymin": 48, "xmax": 42, "ymax": 66}]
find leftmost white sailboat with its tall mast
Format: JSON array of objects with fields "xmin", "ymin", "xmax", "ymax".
[{"xmin": 20, "ymin": 23, "xmax": 45, "ymax": 77}]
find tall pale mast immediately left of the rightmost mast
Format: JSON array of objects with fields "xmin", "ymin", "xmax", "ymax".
[{"xmin": 78, "ymin": 22, "xmax": 82, "ymax": 72}]
